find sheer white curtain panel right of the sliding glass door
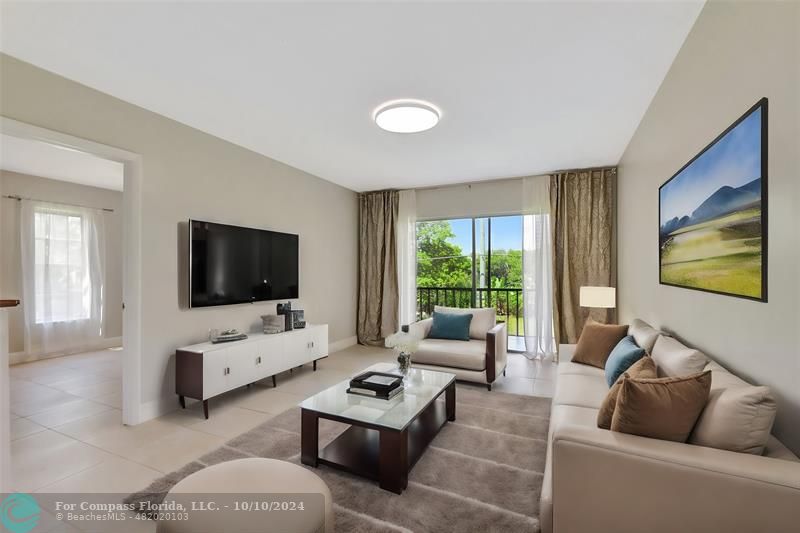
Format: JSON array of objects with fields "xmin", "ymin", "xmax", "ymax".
[{"xmin": 522, "ymin": 176, "xmax": 556, "ymax": 356}]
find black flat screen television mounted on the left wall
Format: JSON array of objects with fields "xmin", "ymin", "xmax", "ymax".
[{"xmin": 189, "ymin": 220, "xmax": 299, "ymax": 307}]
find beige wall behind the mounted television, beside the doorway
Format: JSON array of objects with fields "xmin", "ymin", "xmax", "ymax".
[{"xmin": 0, "ymin": 55, "xmax": 358, "ymax": 416}]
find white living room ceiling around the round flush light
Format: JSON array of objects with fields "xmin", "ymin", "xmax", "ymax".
[{"xmin": 0, "ymin": 0, "xmax": 703, "ymax": 191}]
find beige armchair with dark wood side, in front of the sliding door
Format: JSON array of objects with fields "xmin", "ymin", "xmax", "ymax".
[{"xmin": 409, "ymin": 306, "xmax": 508, "ymax": 390}]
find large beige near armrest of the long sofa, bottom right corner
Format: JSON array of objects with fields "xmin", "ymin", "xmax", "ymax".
[{"xmin": 552, "ymin": 424, "xmax": 800, "ymax": 533}]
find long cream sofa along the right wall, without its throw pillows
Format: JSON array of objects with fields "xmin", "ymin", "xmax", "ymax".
[{"xmin": 540, "ymin": 321, "xmax": 800, "ymax": 533}]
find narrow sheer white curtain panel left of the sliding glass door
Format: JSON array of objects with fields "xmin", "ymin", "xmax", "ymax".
[{"xmin": 397, "ymin": 189, "xmax": 417, "ymax": 326}]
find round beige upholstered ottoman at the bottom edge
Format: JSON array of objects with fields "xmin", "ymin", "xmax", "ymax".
[{"xmin": 156, "ymin": 458, "xmax": 333, "ymax": 533}]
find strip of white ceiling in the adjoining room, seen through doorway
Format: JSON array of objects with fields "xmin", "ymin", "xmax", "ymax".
[{"xmin": 0, "ymin": 134, "xmax": 124, "ymax": 191}]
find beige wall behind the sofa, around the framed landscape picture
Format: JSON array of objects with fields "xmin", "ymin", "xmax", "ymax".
[{"xmin": 618, "ymin": 2, "xmax": 800, "ymax": 452}]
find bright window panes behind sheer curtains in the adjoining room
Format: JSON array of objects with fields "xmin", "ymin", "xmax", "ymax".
[{"xmin": 34, "ymin": 209, "xmax": 92, "ymax": 324}]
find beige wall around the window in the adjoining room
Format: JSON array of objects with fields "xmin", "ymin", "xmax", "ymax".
[{"xmin": 0, "ymin": 171, "xmax": 122, "ymax": 353}]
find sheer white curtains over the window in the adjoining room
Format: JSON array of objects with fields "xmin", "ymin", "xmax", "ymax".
[{"xmin": 20, "ymin": 200, "xmax": 105, "ymax": 355}]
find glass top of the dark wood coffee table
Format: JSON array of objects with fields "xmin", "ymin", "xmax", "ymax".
[{"xmin": 300, "ymin": 363, "xmax": 456, "ymax": 430}]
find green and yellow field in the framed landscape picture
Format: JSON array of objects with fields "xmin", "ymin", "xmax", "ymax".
[{"xmin": 661, "ymin": 208, "xmax": 761, "ymax": 298}]
